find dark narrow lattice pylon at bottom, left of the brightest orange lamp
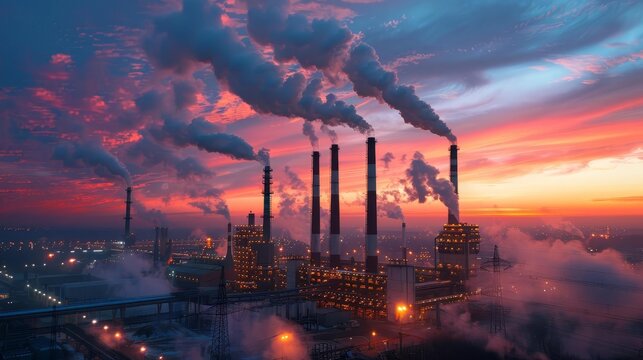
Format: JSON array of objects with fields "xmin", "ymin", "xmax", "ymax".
[{"xmin": 210, "ymin": 267, "xmax": 231, "ymax": 360}]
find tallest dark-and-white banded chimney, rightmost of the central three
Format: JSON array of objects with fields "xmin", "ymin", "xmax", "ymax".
[{"xmin": 366, "ymin": 137, "xmax": 377, "ymax": 274}]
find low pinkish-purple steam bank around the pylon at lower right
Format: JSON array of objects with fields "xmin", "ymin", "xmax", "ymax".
[{"xmin": 450, "ymin": 225, "xmax": 643, "ymax": 358}]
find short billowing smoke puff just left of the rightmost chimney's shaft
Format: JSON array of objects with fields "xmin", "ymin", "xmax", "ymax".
[{"xmin": 404, "ymin": 151, "xmax": 460, "ymax": 217}]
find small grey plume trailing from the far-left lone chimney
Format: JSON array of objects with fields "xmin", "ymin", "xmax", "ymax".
[{"xmin": 53, "ymin": 142, "xmax": 132, "ymax": 186}]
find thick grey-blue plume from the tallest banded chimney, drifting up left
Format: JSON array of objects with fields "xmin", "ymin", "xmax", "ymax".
[{"xmin": 144, "ymin": 0, "xmax": 372, "ymax": 133}]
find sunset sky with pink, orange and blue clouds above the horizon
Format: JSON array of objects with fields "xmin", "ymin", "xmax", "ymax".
[{"xmin": 0, "ymin": 0, "xmax": 643, "ymax": 233}]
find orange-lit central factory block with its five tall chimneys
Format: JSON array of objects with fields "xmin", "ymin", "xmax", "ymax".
[{"xmin": 160, "ymin": 137, "xmax": 480, "ymax": 322}]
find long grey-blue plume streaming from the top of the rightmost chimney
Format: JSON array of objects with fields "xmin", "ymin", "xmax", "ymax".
[{"xmin": 247, "ymin": 1, "xmax": 456, "ymax": 143}]
